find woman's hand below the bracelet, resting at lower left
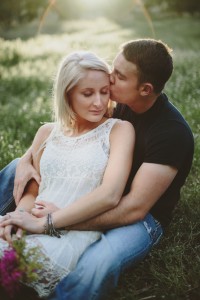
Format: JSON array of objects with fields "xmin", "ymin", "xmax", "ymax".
[{"xmin": 0, "ymin": 210, "xmax": 46, "ymax": 233}]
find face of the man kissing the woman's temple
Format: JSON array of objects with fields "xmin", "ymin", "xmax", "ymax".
[{"xmin": 110, "ymin": 53, "xmax": 140, "ymax": 106}]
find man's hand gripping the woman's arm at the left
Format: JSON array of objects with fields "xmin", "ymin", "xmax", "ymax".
[{"xmin": 13, "ymin": 158, "xmax": 40, "ymax": 205}]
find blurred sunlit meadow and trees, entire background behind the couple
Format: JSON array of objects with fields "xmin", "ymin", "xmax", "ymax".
[{"xmin": 0, "ymin": 0, "xmax": 200, "ymax": 300}]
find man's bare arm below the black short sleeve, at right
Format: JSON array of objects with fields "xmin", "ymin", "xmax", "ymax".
[{"xmin": 69, "ymin": 163, "xmax": 178, "ymax": 231}]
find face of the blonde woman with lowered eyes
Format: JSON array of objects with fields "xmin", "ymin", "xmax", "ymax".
[{"xmin": 69, "ymin": 70, "xmax": 110, "ymax": 122}]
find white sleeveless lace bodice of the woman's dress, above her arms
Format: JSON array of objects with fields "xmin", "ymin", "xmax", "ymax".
[{"xmin": 36, "ymin": 119, "xmax": 117, "ymax": 207}]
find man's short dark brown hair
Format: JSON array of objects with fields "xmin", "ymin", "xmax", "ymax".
[{"xmin": 122, "ymin": 39, "xmax": 173, "ymax": 93}]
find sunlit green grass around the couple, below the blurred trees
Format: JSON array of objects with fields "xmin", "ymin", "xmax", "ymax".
[{"xmin": 0, "ymin": 14, "xmax": 200, "ymax": 300}]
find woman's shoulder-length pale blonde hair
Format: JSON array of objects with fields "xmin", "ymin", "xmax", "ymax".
[{"xmin": 53, "ymin": 51, "xmax": 110, "ymax": 128}]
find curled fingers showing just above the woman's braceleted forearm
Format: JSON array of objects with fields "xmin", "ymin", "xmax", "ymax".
[{"xmin": 31, "ymin": 200, "xmax": 60, "ymax": 218}]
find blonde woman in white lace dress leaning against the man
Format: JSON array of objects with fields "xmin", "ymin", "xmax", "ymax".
[{"xmin": 0, "ymin": 51, "xmax": 134, "ymax": 297}]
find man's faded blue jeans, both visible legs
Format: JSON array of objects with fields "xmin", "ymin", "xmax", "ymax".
[{"xmin": 0, "ymin": 160, "xmax": 163, "ymax": 300}]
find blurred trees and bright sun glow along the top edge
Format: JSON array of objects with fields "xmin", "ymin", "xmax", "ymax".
[{"xmin": 0, "ymin": 0, "xmax": 200, "ymax": 38}]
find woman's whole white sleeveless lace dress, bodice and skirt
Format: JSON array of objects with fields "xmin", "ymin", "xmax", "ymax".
[{"xmin": 0, "ymin": 118, "xmax": 117, "ymax": 297}]
